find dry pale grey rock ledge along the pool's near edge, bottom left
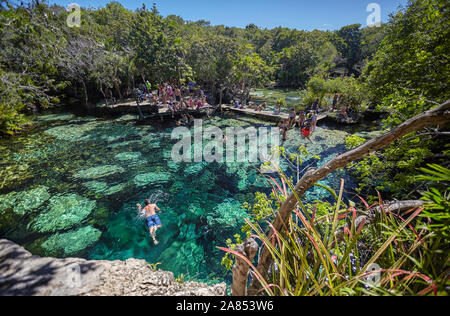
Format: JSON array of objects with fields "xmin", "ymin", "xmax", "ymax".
[{"xmin": 0, "ymin": 239, "xmax": 226, "ymax": 296}]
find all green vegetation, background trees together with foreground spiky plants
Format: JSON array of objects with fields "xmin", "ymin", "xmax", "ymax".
[{"xmin": 0, "ymin": 0, "xmax": 450, "ymax": 295}]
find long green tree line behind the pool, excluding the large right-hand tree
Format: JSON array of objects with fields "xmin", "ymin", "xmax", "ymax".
[{"xmin": 0, "ymin": 1, "xmax": 386, "ymax": 134}]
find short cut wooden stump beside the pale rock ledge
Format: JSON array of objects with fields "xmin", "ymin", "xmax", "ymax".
[{"xmin": 231, "ymin": 238, "xmax": 258, "ymax": 296}]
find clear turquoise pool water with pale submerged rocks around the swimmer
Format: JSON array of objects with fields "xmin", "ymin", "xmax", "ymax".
[{"xmin": 0, "ymin": 113, "xmax": 362, "ymax": 282}]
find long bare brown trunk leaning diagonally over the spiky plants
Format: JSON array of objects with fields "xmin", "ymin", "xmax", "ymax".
[{"xmin": 251, "ymin": 100, "xmax": 450, "ymax": 294}]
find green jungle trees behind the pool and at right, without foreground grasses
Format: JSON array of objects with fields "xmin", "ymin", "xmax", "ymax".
[{"xmin": 0, "ymin": 0, "xmax": 450, "ymax": 200}]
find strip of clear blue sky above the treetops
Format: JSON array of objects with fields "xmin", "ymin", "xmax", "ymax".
[{"xmin": 49, "ymin": 0, "xmax": 407, "ymax": 30}]
